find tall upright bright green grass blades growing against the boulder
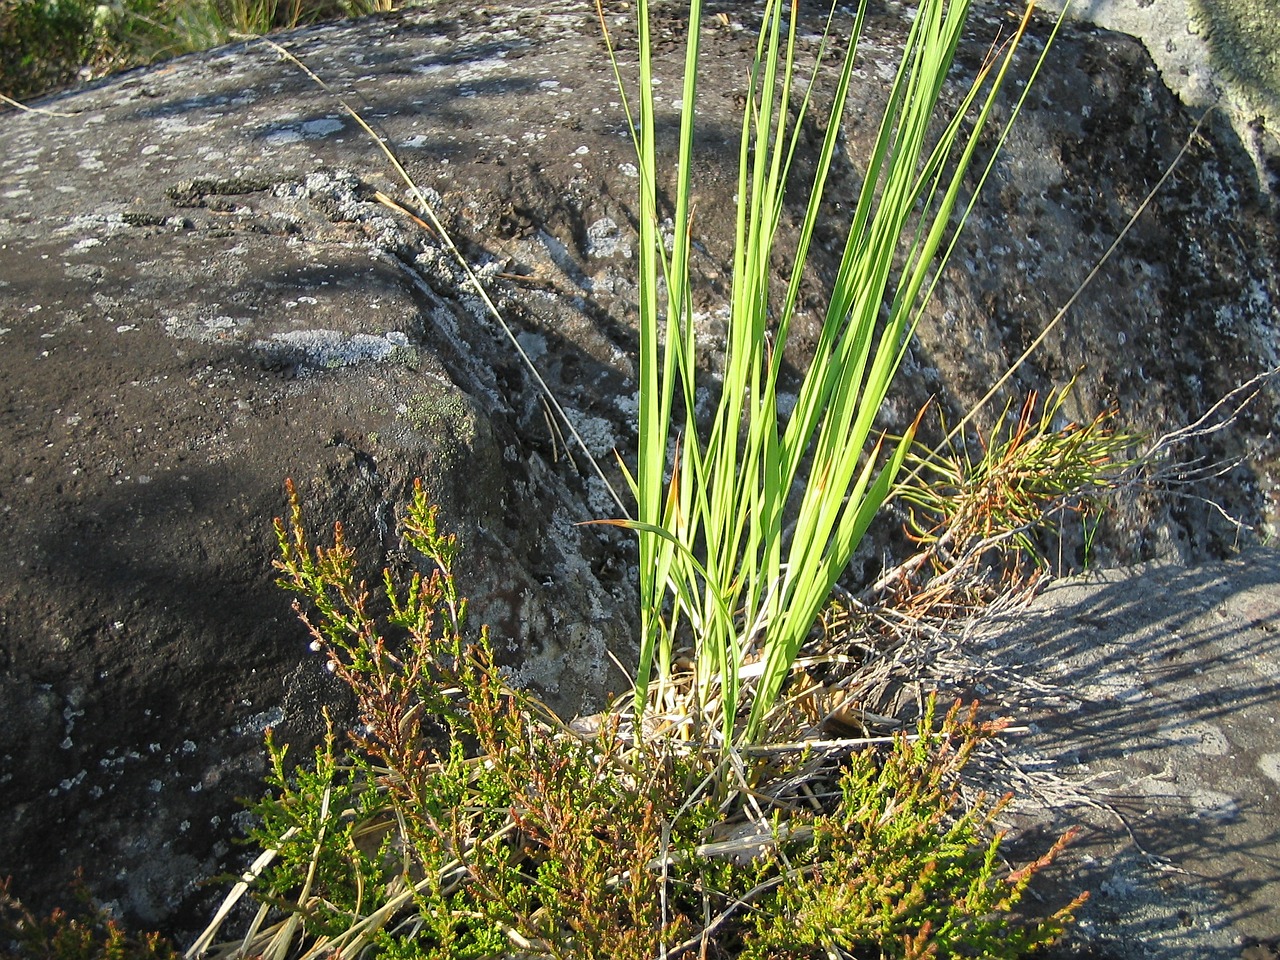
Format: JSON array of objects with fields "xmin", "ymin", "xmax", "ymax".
[{"xmin": 600, "ymin": 0, "xmax": 1064, "ymax": 745}]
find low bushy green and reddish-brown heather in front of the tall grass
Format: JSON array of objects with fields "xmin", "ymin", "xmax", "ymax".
[{"xmin": 187, "ymin": 486, "xmax": 1078, "ymax": 960}]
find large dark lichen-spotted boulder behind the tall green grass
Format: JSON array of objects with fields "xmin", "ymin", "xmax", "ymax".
[{"xmin": 0, "ymin": 0, "xmax": 1280, "ymax": 931}]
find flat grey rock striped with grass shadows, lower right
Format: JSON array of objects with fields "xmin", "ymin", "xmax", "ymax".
[{"xmin": 972, "ymin": 549, "xmax": 1280, "ymax": 960}]
